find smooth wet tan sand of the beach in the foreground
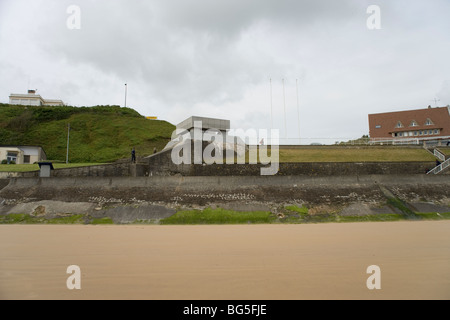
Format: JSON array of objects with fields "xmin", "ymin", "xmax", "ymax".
[{"xmin": 0, "ymin": 221, "xmax": 450, "ymax": 300}]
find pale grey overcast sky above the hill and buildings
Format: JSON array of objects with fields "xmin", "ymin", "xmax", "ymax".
[{"xmin": 0, "ymin": 0, "xmax": 450, "ymax": 144}]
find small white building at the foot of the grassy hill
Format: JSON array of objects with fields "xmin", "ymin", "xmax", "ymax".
[{"xmin": 0, "ymin": 145, "xmax": 47, "ymax": 164}]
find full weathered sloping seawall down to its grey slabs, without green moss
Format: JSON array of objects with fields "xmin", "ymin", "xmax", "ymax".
[{"xmin": 0, "ymin": 174, "xmax": 450, "ymax": 223}]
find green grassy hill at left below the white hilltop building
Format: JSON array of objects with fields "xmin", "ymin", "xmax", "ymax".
[{"xmin": 0, "ymin": 104, "xmax": 175, "ymax": 163}]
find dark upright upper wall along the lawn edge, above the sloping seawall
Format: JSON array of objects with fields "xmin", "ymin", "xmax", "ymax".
[{"xmin": 0, "ymin": 158, "xmax": 440, "ymax": 179}]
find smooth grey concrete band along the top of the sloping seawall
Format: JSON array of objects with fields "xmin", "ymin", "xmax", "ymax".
[{"xmin": 3, "ymin": 174, "xmax": 450, "ymax": 190}]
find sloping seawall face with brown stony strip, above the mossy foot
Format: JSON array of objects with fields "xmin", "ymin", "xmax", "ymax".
[{"xmin": 0, "ymin": 175, "xmax": 450, "ymax": 204}]
